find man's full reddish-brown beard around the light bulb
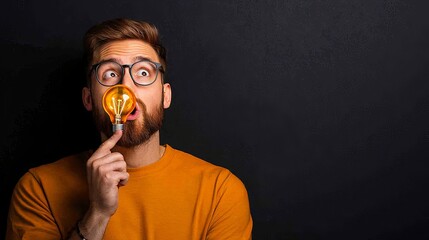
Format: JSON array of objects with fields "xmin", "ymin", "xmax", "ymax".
[{"xmin": 92, "ymin": 98, "xmax": 164, "ymax": 148}]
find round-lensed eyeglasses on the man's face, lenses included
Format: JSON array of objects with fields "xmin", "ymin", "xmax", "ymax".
[{"xmin": 91, "ymin": 60, "xmax": 164, "ymax": 87}]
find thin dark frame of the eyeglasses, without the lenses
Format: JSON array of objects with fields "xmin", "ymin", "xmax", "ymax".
[{"xmin": 89, "ymin": 60, "xmax": 164, "ymax": 87}]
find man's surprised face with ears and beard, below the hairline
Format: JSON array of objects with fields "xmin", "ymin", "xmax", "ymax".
[{"xmin": 82, "ymin": 40, "xmax": 171, "ymax": 147}]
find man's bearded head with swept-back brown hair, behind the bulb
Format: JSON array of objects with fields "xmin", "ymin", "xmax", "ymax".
[{"xmin": 82, "ymin": 19, "xmax": 171, "ymax": 147}]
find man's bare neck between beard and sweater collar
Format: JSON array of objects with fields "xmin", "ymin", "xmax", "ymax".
[{"xmin": 112, "ymin": 132, "xmax": 165, "ymax": 168}]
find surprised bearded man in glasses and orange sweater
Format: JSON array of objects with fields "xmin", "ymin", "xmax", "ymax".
[{"xmin": 6, "ymin": 19, "xmax": 253, "ymax": 240}]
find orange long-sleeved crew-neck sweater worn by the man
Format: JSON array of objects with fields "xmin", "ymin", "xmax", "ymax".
[{"xmin": 6, "ymin": 145, "xmax": 253, "ymax": 240}]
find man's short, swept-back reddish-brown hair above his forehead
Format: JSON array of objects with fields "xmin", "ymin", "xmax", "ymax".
[{"xmin": 83, "ymin": 18, "xmax": 167, "ymax": 83}]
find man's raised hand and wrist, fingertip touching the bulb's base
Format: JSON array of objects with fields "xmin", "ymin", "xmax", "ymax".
[{"xmin": 69, "ymin": 131, "xmax": 129, "ymax": 240}]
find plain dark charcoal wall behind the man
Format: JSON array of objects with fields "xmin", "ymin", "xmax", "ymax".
[{"xmin": 0, "ymin": 0, "xmax": 429, "ymax": 240}]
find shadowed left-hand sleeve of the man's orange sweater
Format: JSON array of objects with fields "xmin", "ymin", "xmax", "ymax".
[{"xmin": 6, "ymin": 172, "xmax": 61, "ymax": 240}]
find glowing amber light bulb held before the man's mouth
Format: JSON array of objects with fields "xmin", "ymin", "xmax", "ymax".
[{"xmin": 103, "ymin": 84, "xmax": 136, "ymax": 131}]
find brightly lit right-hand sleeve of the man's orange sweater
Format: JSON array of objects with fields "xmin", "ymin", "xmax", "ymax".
[{"xmin": 207, "ymin": 170, "xmax": 253, "ymax": 240}]
